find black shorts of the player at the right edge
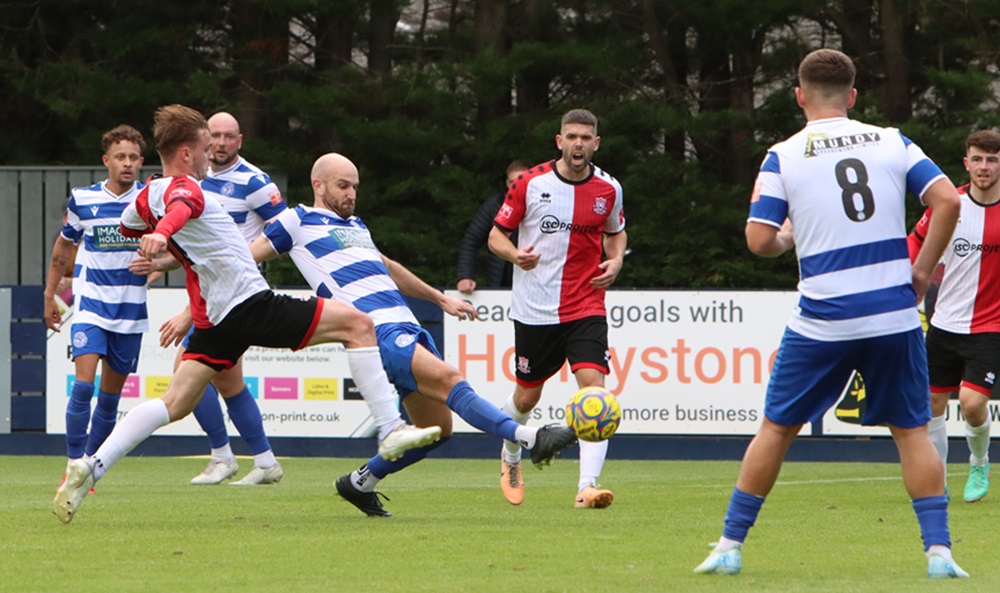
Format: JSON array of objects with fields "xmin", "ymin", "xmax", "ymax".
[{"xmin": 927, "ymin": 325, "xmax": 1000, "ymax": 396}]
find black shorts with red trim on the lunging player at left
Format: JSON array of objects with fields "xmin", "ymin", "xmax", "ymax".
[{"xmin": 182, "ymin": 290, "xmax": 323, "ymax": 371}]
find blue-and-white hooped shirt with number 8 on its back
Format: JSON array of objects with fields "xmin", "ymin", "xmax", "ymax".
[{"xmin": 749, "ymin": 118, "xmax": 944, "ymax": 341}]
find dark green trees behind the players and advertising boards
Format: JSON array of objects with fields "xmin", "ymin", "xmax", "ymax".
[{"xmin": 0, "ymin": 0, "xmax": 1000, "ymax": 288}]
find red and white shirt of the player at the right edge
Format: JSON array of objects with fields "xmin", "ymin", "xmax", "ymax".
[{"xmin": 909, "ymin": 184, "xmax": 1000, "ymax": 334}]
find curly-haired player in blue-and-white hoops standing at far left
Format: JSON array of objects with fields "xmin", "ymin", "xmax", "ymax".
[{"xmin": 44, "ymin": 125, "xmax": 148, "ymax": 480}]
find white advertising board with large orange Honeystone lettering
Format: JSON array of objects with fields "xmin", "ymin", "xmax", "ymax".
[{"xmin": 444, "ymin": 291, "xmax": 797, "ymax": 435}]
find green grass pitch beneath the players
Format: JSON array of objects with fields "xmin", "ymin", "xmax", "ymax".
[{"xmin": 0, "ymin": 457, "xmax": 1000, "ymax": 593}]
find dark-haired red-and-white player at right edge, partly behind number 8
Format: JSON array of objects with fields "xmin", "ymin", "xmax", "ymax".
[{"xmin": 908, "ymin": 130, "xmax": 1000, "ymax": 502}]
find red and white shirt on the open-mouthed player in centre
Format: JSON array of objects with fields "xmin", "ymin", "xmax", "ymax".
[{"xmin": 493, "ymin": 161, "xmax": 625, "ymax": 325}]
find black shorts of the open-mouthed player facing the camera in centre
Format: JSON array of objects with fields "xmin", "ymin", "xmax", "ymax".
[{"xmin": 514, "ymin": 316, "xmax": 611, "ymax": 387}]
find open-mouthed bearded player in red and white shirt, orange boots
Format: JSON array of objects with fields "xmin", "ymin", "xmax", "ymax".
[{"xmin": 489, "ymin": 109, "xmax": 627, "ymax": 508}]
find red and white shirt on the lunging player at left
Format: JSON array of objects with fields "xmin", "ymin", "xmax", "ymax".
[{"xmin": 122, "ymin": 176, "xmax": 268, "ymax": 328}]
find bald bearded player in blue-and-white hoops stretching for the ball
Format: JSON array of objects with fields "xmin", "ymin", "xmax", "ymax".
[{"xmin": 250, "ymin": 153, "xmax": 576, "ymax": 517}]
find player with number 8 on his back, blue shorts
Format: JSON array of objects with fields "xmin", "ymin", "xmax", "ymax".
[{"xmin": 695, "ymin": 49, "xmax": 969, "ymax": 578}]
